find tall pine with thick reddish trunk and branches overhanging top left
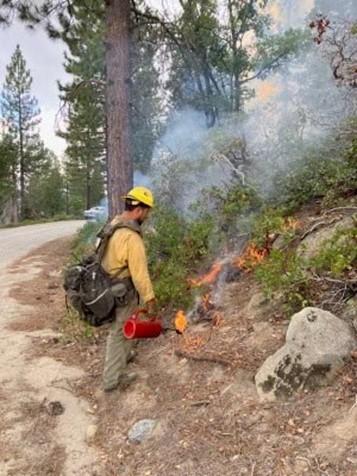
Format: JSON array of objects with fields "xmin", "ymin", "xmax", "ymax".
[{"xmin": 0, "ymin": 0, "xmax": 133, "ymax": 216}]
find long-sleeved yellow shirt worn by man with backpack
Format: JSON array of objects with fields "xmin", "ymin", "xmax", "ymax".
[{"xmin": 102, "ymin": 221, "xmax": 155, "ymax": 304}]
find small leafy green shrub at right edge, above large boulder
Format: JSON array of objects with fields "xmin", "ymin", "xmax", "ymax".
[{"xmin": 311, "ymin": 226, "xmax": 357, "ymax": 278}]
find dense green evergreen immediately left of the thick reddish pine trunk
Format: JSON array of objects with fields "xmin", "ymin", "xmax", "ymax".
[{"xmin": 60, "ymin": 2, "xmax": 106, "ymax": 214}]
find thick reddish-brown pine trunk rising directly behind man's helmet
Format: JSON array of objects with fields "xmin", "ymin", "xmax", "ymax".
[{"xmin": 106, "ymin": 0, "xmax": 133, "ymax": 217}]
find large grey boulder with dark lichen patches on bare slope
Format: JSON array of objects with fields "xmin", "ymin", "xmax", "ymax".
[{"xmin": 255, "ymin": 307, "xmax": 356, "ymax": 401}]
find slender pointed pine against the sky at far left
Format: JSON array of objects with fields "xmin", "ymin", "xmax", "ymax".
[{"xmin": 1, "ymin": 45, "xmax": 43, "ymax": 218}]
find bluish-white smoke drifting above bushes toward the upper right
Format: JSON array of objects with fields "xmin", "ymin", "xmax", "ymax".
[{"xmin": 152, "ymin": 0, "xmax": 356, "ymax": 213}]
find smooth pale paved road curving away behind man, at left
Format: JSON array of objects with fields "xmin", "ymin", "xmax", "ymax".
[{"xmin": 0, "ymin": 220, "xmax": 85, "ymax": 271}]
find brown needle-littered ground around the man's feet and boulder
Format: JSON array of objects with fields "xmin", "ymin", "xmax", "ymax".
[{"xmin": 0, "ymin": 217, "xmax": 357, "ymax": 476}]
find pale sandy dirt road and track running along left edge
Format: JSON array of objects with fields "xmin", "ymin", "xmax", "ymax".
[{"xmin": 0, "ymin": 221, "xmax": 102, "ymax": 476}]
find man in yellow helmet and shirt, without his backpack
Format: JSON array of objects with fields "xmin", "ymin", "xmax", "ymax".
[{"xmin": 102, "ymin": 187, "xmax": 155, "ymax": 392}]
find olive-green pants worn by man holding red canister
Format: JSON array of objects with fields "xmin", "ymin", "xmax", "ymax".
[{"xmin": 103, "ymin": 296, "xmax": 138, "ymax": 390}]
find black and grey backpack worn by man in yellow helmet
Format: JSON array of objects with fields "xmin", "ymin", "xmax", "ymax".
[{"xmin": 63, "ymin": 221, "xmax": 141, "ymax": 327}]
